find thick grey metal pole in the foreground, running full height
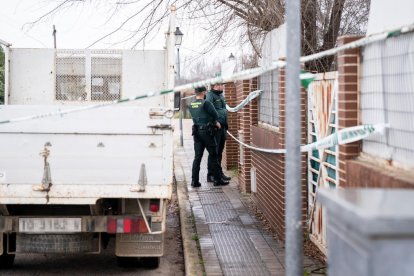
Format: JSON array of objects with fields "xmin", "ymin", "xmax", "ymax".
[{"xmin": 285, "ymin": 0, "xmax": 303, "ymax": 276}]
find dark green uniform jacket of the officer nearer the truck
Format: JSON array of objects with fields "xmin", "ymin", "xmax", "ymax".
[{"xmin": 189, "ymin": 99, "xmax": 219, "ymax": 126}]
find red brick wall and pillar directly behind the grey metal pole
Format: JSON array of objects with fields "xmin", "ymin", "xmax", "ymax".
[{"xmin": 251, "ymin": 69, "xmax": 307, "ymax": 239}]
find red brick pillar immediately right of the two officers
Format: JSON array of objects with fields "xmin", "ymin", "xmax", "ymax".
[{"xmin": 221, "ymin": 82, "xmax": 239, "ymax": 170}]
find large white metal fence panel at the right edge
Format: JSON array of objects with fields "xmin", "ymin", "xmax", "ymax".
[{"xmin": 360, "ymin": 33, "xmax": 414, "ymax": 167}]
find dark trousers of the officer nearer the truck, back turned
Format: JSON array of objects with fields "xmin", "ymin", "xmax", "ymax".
[{"xmin": 192, "ymin": 130, "xmax": 223, "ymax": 182}]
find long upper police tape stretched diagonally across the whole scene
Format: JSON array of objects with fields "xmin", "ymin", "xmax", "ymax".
[{"xmin": 0, "ymin": 23, "xmax": 414, "ymax": 124}]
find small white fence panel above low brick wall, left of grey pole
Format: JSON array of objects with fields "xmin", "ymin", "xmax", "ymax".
[{"xmin": 259, "ymin": 70, "xmax": 279, "ymax": 126}]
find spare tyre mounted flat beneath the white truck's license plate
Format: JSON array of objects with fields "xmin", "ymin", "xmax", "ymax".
[{"xmin": 16, "ymin": 233, "xmax": 94, "ymax": 253}]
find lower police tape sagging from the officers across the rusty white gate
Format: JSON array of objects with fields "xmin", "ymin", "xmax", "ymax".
[{"xmin": 227, "ymin": 124, "xmax": 389, "ymax": 154}]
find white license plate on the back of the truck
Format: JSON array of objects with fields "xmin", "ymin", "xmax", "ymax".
[{"xmin": 19, "ymin": 218, "xmax": 82, "ymax": 233}]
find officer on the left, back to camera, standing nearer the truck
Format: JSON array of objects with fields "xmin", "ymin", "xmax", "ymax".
[{"xmin": 189, "ymin": 87, "xmax": 229, "ymax": 187}]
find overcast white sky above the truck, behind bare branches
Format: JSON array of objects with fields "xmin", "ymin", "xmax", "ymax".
[{"xmin": 0, "ymin": 0, "xmax": 241, "ymax": 77}]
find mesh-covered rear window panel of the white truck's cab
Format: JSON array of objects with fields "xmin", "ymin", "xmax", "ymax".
[{"xmin": 55, "ymin": 50, "xmax": 122, "ymax": 102}]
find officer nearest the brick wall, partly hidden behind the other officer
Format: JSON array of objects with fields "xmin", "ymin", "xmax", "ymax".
[{"xmin": 206, "ymin": 83, "xmax": 231, "ymax": 182}]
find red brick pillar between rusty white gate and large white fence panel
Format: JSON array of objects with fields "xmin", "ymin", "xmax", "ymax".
[{"xmin": 338, "ymin": 36, "xmax": 361, "ymax": 187}]
